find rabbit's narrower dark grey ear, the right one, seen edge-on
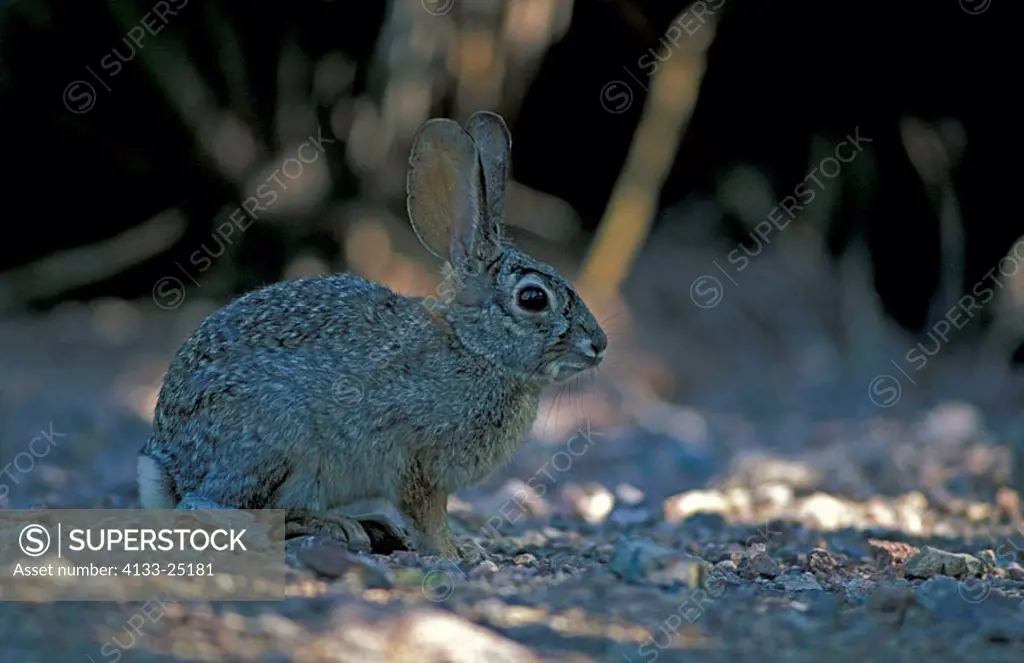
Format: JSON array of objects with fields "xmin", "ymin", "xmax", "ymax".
[{"xmin": 466, "ymin": 111, "xmax": 512, "ymax": 238}]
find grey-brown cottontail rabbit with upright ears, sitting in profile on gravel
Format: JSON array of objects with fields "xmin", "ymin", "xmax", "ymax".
[{"xmin": 138, "ymin": 111, "xmax": 607, "ymax": 557}]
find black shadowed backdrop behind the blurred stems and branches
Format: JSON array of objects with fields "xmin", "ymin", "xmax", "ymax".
[{"xmin": 0, "ymin": 0, "xmax": 1007, "ymax": 331}]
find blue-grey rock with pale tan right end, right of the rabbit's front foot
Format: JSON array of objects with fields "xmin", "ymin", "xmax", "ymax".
[{"xmin": 608, "ymin": 537, "xmax": 711, "ymax": 588}]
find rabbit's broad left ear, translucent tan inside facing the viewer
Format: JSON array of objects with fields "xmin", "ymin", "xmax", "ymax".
[{"xmin": 406, "ymin": 118, "xmax": 483, "ymax": 266}]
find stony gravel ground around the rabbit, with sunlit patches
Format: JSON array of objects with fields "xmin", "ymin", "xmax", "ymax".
[{"xmin": 0, "ymin": 291, "xmax": 1024, "ymax": 663}]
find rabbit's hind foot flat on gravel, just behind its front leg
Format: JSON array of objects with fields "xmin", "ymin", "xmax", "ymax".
[{"xmin": 285, "ymin": 509, "xmax": 409, "ymax": 554}]
